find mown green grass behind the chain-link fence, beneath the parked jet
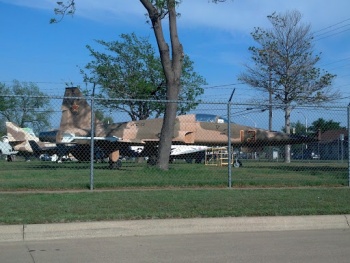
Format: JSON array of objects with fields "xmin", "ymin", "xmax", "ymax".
[{"xmin": 0, "ymin": 160, "xmax": 348, "ymax": 191}]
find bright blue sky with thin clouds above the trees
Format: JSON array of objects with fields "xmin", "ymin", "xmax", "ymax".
[{"xmin": 0, "ymin": 0, "xmax": 350, "ymax": 128}]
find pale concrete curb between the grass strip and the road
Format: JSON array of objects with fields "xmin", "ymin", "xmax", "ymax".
[{"xmin": 0, "ymin": 215, "xmax": 350, "ymax": 242}]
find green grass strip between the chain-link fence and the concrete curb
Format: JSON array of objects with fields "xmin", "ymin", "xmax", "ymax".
[{"xmin": 0, "ymin": 188, "xmax": 350, "ymax": 224}]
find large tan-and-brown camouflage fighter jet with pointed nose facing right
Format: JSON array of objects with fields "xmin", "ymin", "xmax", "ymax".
[{"xmin": 56, "ymin": 87, "xmax": 317, "ymax": 168}]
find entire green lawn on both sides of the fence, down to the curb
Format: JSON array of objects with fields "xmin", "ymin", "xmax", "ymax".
[{"xmin": 0, "ymin": 161, "xmax": 350, "ymax": 224}]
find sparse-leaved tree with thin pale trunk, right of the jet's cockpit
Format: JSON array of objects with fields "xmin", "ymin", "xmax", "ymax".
[{"xmin": 239, "ymin": 11, "xmax": 339, "ymax": 162}]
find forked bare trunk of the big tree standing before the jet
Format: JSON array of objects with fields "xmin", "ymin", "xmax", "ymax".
[{"xmin": 140, "ymin": 0, "xmax": 183, "ymax": 170}]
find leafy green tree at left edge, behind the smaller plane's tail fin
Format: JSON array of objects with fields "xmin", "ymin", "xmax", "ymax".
[{"xmin": 0, "ymin": 80, "xmax": 53, "ymax": 132}]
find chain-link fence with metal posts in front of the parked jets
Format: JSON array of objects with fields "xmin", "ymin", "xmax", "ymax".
[{"xmin": 0, "ymin": 92, "xmax": 350, "ymax": 190}]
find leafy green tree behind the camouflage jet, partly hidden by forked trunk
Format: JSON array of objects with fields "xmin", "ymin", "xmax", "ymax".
[{"xmin": 82, "ymin": 33, "xmax": 206, "ymax": 120}]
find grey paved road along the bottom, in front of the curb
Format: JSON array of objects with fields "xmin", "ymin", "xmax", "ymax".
[{"xmin": 0, "ymin": 229, "xmax": 350, "ymax": 263}]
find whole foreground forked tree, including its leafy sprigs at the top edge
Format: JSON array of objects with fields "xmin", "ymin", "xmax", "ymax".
[{"xmin": 50, "ymin": 0, "xmax": 225, "ymax": 170}]
